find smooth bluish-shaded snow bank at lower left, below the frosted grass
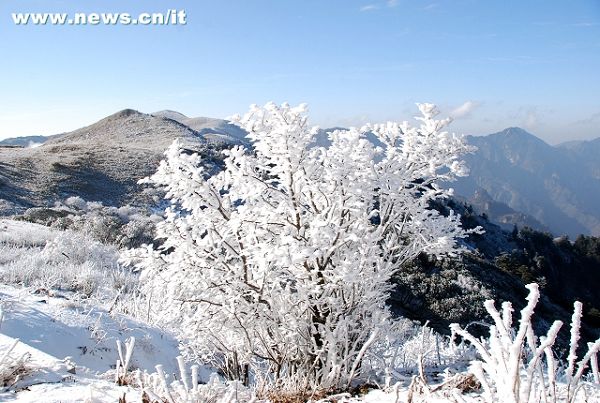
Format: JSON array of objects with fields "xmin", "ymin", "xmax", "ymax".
[{"xmin": 0, "ymin": 286, "xmax": 179, "ymax": 374}]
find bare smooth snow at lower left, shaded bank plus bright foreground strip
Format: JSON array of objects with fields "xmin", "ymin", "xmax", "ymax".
[{"xmin": 0, "ymin": 285, "xmax": 179, "ymax": 402}]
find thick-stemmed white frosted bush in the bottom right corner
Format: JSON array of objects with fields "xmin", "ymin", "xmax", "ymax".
[{"xmin": 451, "ymin": 284, "xmax": 600, "ymax": 403}]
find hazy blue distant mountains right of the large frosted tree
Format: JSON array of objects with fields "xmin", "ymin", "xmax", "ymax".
[{"xmin": 453, "ymin": 127, "xmax": 600, "ymax": 237}]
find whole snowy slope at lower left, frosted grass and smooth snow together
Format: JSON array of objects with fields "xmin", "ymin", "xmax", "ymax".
[{"xmin": 0, "ymin": 219, "xmax": 179, "ymax": 402}]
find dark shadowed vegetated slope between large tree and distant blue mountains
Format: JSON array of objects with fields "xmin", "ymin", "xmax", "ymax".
[{"xmin": 390, "ymin": 201, "xmax": 600, "ymax": 354}]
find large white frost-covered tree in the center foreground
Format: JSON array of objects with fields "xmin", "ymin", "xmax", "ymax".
[{"xmin": 125, "ymin": 103, "xmax": 478, "ymax": 396}]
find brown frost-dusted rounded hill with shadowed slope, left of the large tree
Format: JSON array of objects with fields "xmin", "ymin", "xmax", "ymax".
[{"xmin": 0, "ymin": 109, "xmax": 211, "ymax": 214}]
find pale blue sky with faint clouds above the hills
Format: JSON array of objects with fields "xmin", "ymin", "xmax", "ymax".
[{"xmin": 0, "ymin": 0, "xmax": 600, "ymax": 143}]
